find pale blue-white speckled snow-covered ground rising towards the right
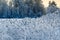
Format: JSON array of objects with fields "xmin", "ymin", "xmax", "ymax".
[{"xmin": 0, "ymin": 12, "xmax": 60, "ymax": 40}]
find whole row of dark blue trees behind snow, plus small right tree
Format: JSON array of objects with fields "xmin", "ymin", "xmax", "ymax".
[{"xmin": 0, "ymin": 0, "xmax": 57, "ymax": 18}]
